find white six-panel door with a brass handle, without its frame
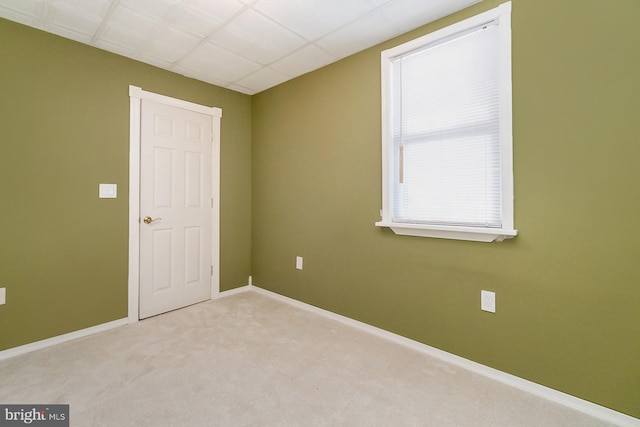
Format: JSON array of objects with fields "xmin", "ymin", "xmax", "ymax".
[{"xmin": 139, "ymin": 99, "xmax": 213, "ymax": 319}]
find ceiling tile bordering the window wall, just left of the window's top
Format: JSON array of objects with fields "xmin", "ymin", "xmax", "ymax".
[{"xmin": 316, "ymin": 11, "xmax": 398, "ymax": 58}]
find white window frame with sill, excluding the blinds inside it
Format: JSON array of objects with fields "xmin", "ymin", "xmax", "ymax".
[{"xmin": 375, "ymin": 2, "xmax": 518, "ymax": 242}]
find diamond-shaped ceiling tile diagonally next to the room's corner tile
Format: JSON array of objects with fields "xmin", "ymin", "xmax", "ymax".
[{"xmin": 211, "ymin": 10, "xmax": 304, "ymax": 64}]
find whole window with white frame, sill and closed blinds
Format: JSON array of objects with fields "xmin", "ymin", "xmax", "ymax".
[{"xmin": 376, "ymin": 3, "xmax": 517, "ymax": 242}]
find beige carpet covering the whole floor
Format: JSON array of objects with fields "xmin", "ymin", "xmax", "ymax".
[{"xmin": 0, "ymin": 292, "xmax": 620, "ymax": 427}]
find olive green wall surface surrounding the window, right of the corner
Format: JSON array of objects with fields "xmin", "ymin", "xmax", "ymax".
[{"xmin": 252, "ymin": 0, "xmax": 640, "ymax": 417}]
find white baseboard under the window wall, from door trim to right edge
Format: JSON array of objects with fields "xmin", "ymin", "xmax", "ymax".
[{"xmin": 249, "ymin": 285, "xmax": 640, "ymax": 427}]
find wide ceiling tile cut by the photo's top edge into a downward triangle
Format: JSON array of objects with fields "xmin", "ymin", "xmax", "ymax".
[{"xmin": 255, "ymin": 0, "xmax": 371, "ymax": 41}]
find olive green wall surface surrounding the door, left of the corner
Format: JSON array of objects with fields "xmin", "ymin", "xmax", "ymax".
[{"xmin": 0, "ymin": 19, "xmax": 251, "ymax": 350}]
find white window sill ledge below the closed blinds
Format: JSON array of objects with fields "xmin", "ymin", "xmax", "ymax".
[{"xmin": 376, "ymin": 221, "xmax": 518, "ymax": 242}]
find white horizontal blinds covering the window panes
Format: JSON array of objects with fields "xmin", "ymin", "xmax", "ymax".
[{"xmin": 391, "ymin": 21, "xmax": 502, "ymax": 228}]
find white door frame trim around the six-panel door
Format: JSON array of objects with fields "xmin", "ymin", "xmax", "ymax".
[{"xmin": 128, "ymin": 85, "xmax": 222, "ymax": 323}]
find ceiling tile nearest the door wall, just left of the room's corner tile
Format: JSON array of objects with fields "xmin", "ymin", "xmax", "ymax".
[{"xmin": 178, "ymin": 43, "xmax": 261, "ymax": 82}]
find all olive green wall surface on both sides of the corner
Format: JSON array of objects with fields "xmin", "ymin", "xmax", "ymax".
[{"xmin": 0, "ymin": 0, "xmax": 640, "ymax": 417}]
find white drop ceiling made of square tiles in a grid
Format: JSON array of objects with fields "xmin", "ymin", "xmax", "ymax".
[{"xmin": 0, "ymin": 0, "xmax": 480, "ymax": 95}]
